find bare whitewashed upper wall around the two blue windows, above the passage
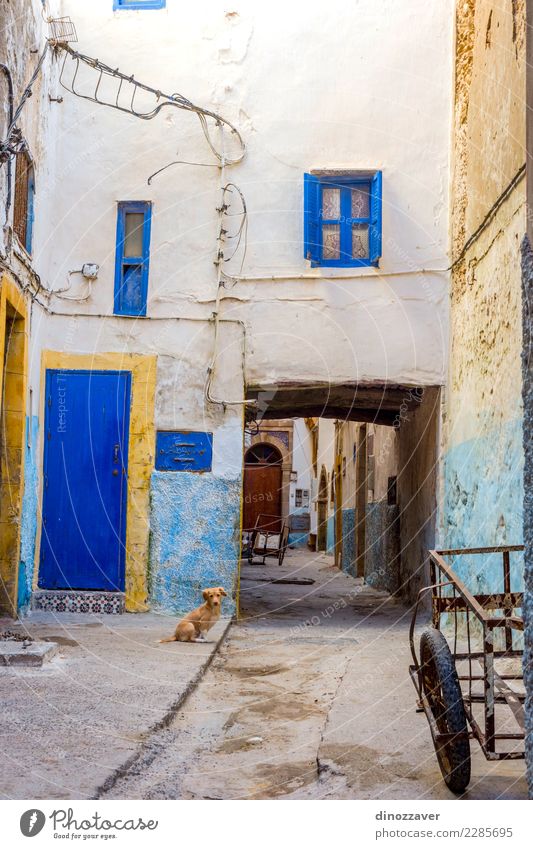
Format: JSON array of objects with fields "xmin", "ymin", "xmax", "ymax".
[{"xmin": 33, "ymin": 0, "xmax": 453, "ymax": 426}]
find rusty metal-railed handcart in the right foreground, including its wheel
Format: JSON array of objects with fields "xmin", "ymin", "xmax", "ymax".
[{"xmin": 409, "ymin": 545, "xmax": 525, "ymax": 793}]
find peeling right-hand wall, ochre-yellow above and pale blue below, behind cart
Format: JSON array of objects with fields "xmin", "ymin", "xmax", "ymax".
[{"xmin": 439, "ymin": 0, "xmax": 526, "ymax": 591}]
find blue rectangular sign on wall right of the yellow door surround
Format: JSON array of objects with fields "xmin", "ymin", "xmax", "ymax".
[{"xmin": 155, "ymin": 430, "xmax": 213, "ymax": 472}]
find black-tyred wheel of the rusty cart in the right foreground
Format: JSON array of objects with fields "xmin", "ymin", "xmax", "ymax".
[{"xmin": 420, "ymin": 628, "xmax": 470, "ymax": 793}]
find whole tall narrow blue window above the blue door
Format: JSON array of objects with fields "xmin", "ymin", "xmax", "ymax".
[{"xmin": 113, "ymin": 200, "xmax": 152, "ymax": 316}]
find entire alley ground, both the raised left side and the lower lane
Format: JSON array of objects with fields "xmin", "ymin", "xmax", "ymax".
[{"xmin": 0, "ymin": 550, "xmax": 527, "ymax": 800}]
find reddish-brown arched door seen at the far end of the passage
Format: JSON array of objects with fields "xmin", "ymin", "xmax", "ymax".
[{"xmin": 243, "ymin": 442, "xmax": 282, "ymax": 531}]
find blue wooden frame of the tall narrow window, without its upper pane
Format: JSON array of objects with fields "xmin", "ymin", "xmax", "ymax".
[{"xmin": 113, "ymin": 201, "xmax": 152, "ymax": 316}]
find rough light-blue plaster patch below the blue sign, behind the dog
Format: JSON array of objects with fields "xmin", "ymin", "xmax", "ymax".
[{"xmin": 150, "ymin": 471, "xmax": 242, "ymax": 616}]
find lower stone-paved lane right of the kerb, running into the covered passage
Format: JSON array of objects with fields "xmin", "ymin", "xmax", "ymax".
[{"xmin": 103, "ymin": 551, "xmax": 527, "ymax": 799}]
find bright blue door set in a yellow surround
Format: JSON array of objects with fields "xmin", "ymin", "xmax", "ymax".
[{"xmin": 39, "ymin": 370, "xmax": 131, "ymax": 590}]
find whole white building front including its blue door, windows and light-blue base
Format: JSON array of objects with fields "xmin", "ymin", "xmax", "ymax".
[{"xmin": 1, "ymin": 0, "xmax": 453, "ymax": 611}]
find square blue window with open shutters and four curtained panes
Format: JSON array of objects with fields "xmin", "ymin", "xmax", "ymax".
[{"xmin": 304, "ymin": 171, "xmax": 381, "ymax": 268}]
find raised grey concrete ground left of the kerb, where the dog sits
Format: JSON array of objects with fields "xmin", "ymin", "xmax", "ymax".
[{"xmin": 0, "ymin": 611, "xmax": 229, "ymax": 799}]
